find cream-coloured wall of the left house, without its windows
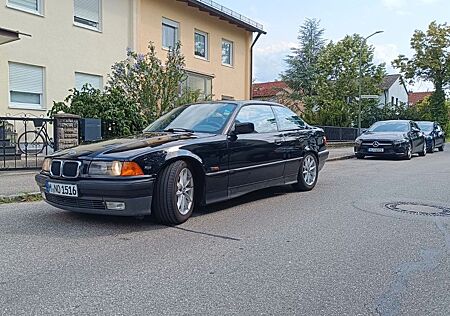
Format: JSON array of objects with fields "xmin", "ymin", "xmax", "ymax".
[{"xmin": 0, "ymin": 0, "xmax": 133, "ymax": 116}]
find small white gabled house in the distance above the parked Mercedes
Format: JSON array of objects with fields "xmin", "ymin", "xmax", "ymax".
[{"xmin": 379, "ymin": 74, "xmax": 408, "ymax": 106}]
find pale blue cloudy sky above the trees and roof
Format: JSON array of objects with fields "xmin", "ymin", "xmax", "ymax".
[{"xmin": 216, "ymin": 0, "xmax": 450, "ymax": 91}]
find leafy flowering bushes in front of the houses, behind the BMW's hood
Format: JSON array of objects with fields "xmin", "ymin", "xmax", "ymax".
[{"xmin": 48, "ymin": 43, "xmax": 191, "ymax": 136}]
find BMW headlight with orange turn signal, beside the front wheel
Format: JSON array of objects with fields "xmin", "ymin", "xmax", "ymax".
[{"xmin": 89, "ymin": 161, "xmax": 144, "ymax": 177}]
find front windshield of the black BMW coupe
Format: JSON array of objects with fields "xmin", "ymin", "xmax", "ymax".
[{"xmin": 144, "ymin": 103, "xmax": 236, "ymax": 134}]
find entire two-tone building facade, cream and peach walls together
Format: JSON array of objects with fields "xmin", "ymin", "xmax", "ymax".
[{"xmin": 0, "ymin": 0, "xmax": 253, "ymax": 116}]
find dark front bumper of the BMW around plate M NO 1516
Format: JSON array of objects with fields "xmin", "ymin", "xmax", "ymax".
[{"xmin": 35, "ymin": 173, "xmax": 155, "ymax": 216}]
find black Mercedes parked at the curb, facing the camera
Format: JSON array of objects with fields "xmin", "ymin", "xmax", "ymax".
[{"xmin": 355, "ymin": 120, "xmax": 427, "ymax": 160}]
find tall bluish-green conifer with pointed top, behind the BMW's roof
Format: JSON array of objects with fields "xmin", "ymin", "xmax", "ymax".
[{"xmin": 281, "ymin": 19, "xmax": 325, "ymax": 121}]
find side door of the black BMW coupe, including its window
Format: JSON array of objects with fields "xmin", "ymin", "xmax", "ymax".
[{"xmin": 228, "ymin": 104, "xmax": 284, "ymax": 197}]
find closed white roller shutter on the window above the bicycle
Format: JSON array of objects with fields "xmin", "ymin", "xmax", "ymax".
[{"xmin": 9, "ymin": 63, "xmax": 44, "ymax": 94}]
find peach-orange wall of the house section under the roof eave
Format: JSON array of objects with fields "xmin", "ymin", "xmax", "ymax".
[{"xmin": 136, "ymin": 0, "xmax": 253, "ymax": 100}]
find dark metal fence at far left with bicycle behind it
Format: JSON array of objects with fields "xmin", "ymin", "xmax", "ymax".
[{"xmin": 0, "ymin": 117, "xmax": 56, "ymax": 170}]
